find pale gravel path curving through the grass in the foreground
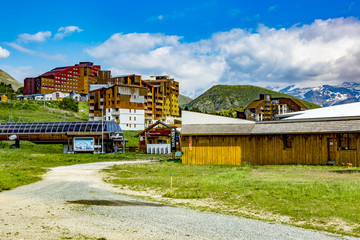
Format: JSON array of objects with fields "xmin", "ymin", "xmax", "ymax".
[{"xmin": 0, "ymin": 161, "xmax": 355, "ymax": 240}]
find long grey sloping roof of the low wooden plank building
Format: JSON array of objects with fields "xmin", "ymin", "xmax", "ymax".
[{"xmin": 181, "ymin": 119, "xmax": 360, "ymax": 135}]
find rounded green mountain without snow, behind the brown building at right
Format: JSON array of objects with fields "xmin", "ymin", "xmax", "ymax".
[{"xmin": 186, "ymin": 85, "xmax": 319, "ymax": 112}]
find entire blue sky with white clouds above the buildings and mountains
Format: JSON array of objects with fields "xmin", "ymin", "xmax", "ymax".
[{"xmin": 0, "ymin": 0, "xmax": 360, "ymax": 97}]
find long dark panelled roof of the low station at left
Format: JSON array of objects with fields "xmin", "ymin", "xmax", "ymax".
[{"xmin": 0, "ymin": 121, "xmax": 122, "ymax": 134}]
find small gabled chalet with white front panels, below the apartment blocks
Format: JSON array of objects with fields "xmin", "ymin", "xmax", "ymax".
[{"xmin": 135, "ymin": 121, "xmax": 181, "ymax": 154}]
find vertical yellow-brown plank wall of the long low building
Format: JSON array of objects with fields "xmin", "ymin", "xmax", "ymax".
[{"xmin": 182, "ymin": 134, "xmax": 360, "ymax": 166}]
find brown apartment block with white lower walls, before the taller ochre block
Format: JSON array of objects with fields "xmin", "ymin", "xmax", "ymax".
[{"xmin": 89, "ymin": 84, "xmax": 147, "ymax": 130}]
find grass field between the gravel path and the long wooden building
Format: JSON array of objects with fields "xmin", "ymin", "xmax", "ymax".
[{"xmin": 105, "ymin": 163, "xmax": 360, "ymax": 236}]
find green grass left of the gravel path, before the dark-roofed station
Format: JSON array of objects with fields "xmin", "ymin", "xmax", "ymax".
[{"xmin": 0, "ymin": 141, "xmax": 164, "ymax": 191}]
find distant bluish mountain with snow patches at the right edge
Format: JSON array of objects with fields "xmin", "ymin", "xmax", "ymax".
[{"xmin": 280, "ymin": 82, "xmax": 360, "ymax": 107}]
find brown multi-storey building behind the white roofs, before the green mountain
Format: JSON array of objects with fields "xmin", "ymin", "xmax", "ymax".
[{"xmin": 243, "ymin": 94, "xmax": 308, "ymax": 121}]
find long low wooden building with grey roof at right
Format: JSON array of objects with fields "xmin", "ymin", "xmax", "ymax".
[{"xmin": 182, "ymin": 111, "xmax": 360, "ymax": 166}]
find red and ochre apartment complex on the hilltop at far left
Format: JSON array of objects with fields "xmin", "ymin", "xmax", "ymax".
[{"xmin": 23, "ymin": 62, "xmax": 101, "ymax": 95}]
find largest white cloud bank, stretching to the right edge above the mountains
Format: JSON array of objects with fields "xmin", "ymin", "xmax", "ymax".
[{"xmin": 86, "ymin": 18, "xmax": 360, "ymax": 96}]
